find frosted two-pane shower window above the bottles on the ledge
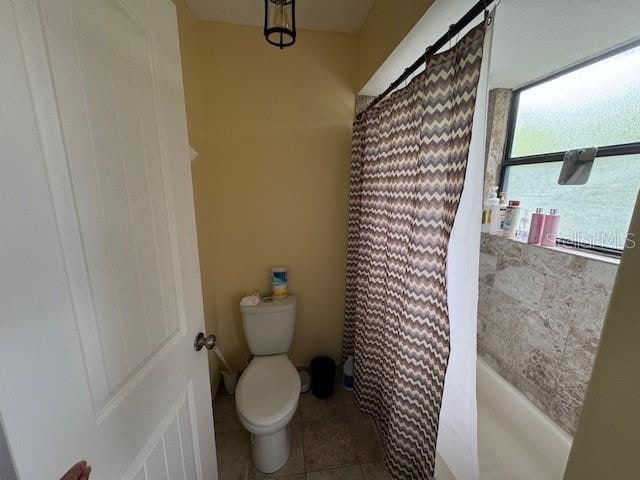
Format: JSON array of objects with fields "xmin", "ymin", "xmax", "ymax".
[{"xmin": 500, "ymin": 45, "xmax": 640, "ymax": 255}]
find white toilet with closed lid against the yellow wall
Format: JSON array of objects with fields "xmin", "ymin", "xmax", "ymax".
[{"xmin": 236, "ymin": 296, "xmax": 300, "ymax": 473}]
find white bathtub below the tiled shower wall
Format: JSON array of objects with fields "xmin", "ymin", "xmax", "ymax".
[{"xmin": 435, "ymin": 358, "xmax": 572, "ymax": 480}]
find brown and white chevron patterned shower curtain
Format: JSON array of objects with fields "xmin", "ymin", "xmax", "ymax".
[{"xmin": 343, "ymin": 24, "xmax": 484, "ymax": 480}]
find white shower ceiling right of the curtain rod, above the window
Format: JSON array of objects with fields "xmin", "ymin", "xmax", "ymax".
[{"xmin": 489, "ymin": 0, "xmax": 640, "ymax": 88}]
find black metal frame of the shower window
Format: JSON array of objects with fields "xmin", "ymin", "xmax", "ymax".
[{"xmin": 498, "ymin": 41, "xmax": 640, "ymax": 257}]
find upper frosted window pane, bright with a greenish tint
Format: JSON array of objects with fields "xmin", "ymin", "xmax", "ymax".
[{"xmin": 511, "ymin": 46, "xmax": 640, "ymax": 158}]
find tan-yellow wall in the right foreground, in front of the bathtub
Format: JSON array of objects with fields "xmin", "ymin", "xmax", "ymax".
[{"xmin": 564, "ymin": 193, "xmax": 640, "ymax": 480}]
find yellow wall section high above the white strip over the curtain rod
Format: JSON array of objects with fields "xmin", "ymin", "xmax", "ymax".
[{"xmin": 357, "ymin": 0, "xmax": 434, "ymax": 91}]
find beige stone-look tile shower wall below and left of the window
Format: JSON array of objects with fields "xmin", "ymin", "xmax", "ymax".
[{"xmin": 478, "ymin": 89, "xmax": 617, "ymax": 435}]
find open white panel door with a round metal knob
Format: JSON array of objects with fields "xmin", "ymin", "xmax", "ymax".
[{"xmin": 0, "ymin": 0, "xmax": 217, "ymax": 480}]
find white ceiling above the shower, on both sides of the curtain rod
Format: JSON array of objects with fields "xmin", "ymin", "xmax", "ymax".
[{"xmin": 360, "ymin": 0, "xmax": 640, "ymax": 95}]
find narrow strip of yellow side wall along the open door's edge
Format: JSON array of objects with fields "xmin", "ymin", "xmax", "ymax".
[{"xmin": 173, "ymin": 0, "xmax": 219, "ymax": 389}]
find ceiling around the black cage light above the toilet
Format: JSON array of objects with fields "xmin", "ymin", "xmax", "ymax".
[{"xmin": 187, "ymin": 0, "xmax": 374, "ymax": 33}]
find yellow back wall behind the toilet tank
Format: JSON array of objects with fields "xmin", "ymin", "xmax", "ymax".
[{"xmin": 194, "ymin": 22, "xmax": 356, "ymax": 368}]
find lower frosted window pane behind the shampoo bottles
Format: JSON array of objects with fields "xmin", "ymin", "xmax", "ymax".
[{"xmin": 504, "ymin": 155, "xmax": 640, "ymax": 249}]
